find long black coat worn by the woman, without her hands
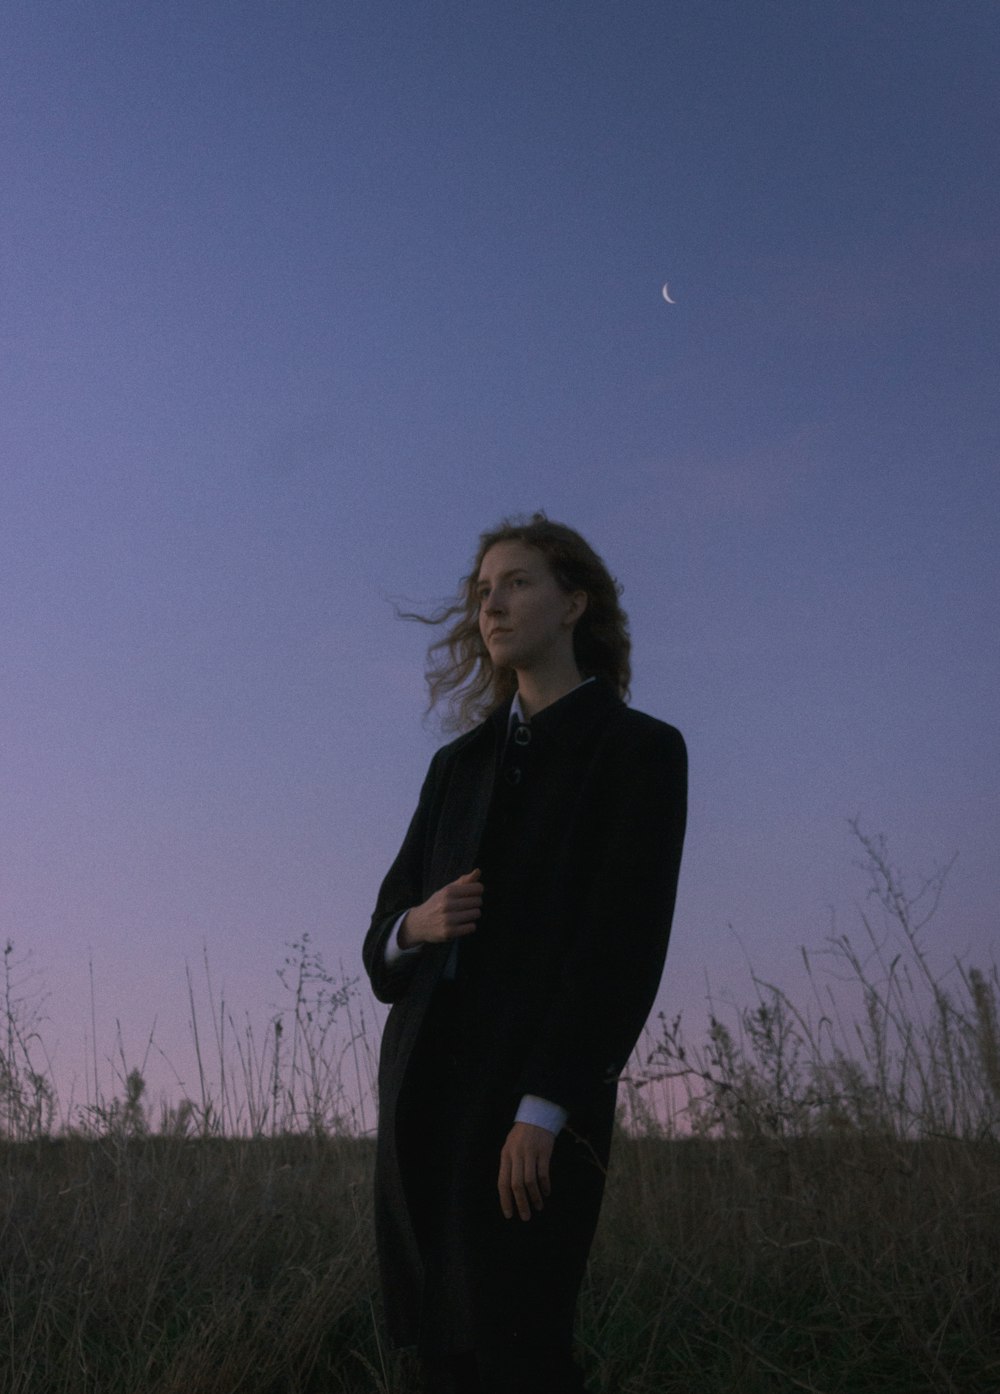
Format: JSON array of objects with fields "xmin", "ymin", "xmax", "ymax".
[{"xmin": 364, "ymin": 680, "xmax": 686, "ymax": 1344}]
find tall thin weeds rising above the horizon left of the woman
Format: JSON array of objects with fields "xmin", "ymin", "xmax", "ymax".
[{"xmin": 0, "ymin": 934, "xmax": 378, "ymax": 1142}]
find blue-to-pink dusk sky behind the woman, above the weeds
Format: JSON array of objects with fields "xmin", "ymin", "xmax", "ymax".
[{"xmin": 0, "ymin": 0, "xmax": 1000, "ymax": 1120}]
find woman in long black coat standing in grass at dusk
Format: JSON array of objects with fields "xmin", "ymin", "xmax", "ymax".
[{"xmin": 364, "ymin": 513, "xmax": 686, "ymax": 1394}]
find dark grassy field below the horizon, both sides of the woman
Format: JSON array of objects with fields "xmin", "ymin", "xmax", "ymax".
[{"xmin": 0, "ymin": 1136, "xmax": 1000, "ymax": 1394}]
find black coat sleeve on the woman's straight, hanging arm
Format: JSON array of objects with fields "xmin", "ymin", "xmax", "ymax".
[{"xmin": 519, "ymin": 718, "xmax": 688, "ymax": 1122}]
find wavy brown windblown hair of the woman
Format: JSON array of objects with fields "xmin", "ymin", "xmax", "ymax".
[{"xmin": 399, "ymin": 513, "xmax": 632, "ymax": 730}]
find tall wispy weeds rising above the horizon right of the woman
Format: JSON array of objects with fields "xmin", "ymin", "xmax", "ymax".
[{"xmin": 644, "ymin": 822, "xmax": 1000, "ymax": 1142}]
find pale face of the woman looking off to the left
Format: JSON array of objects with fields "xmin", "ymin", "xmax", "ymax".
[{"xmin": 477, "ymin": 542, "xmax": 587, "ymax": 672}]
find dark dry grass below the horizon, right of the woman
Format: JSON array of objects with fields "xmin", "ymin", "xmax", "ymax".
[{"xmin": 583, "ymin": 1136, "xmax": 1000, "ymax": 1394}]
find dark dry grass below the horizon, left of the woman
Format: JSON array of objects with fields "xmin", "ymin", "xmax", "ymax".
[{"xmin": 0, "ymin": 1138, "xmax": 379, "ymax": 1394}]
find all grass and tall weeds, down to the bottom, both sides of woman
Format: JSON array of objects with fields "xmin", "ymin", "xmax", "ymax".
[{"xmin": 0, "ymin": 829, "xmax": 1000, "ymax": 1394}]
